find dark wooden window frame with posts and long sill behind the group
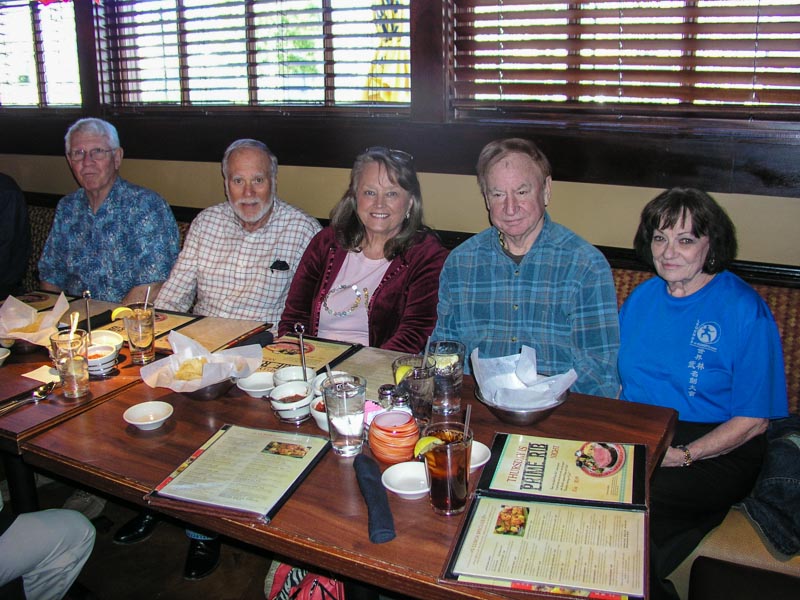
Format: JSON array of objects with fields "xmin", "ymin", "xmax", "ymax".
[{"xmin": 0, "ymin": 0, "xmax": 800, "ymax": 198}]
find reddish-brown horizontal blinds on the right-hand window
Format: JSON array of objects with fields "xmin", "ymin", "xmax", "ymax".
[{"xmin": 454, "ymin": 0, "xmax": 800, "ymax": 108}]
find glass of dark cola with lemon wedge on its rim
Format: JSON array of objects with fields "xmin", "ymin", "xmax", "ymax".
[{"xmin": 422, "ymin": 421, "xmax": 472, "ymax": 516}]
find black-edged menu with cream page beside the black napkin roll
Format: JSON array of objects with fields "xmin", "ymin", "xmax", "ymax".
[{"xmin": 147, "ymin": 425, "xmax": 330, "ymax": 522}]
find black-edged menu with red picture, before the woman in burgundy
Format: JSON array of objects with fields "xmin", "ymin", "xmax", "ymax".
[{"xmin": 258, "ymin": 335, "xmax": 363, "ymax": 371}]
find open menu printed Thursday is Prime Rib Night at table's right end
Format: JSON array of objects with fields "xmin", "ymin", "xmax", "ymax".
[{"xmin": 443, "ymin": 433, "xmax": 647, "ymax": 599}]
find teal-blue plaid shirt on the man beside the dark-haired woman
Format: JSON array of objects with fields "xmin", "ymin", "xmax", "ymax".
[{"xmin": 432, "ymin": 213, "xmax": 619, "ymax": 398}]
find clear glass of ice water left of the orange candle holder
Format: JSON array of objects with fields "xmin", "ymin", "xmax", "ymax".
[{"xmin": 322, "ymin": 375, "xmax": 367, "ymax": 456}]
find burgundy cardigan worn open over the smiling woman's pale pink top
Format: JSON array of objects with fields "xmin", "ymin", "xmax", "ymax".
[{"xmin": 278, "ymin": 227, "xmax": 447, "ymax": 353}]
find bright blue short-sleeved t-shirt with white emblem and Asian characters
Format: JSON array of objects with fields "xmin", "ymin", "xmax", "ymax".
[{"xmin": 619, "ymin": 271, "xmax": 788, "ymax": 423}]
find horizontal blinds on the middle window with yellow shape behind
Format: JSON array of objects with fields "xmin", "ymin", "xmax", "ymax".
[{"xmin": 106, "ymin": 0, "xmax": 410, "ymax": 106}]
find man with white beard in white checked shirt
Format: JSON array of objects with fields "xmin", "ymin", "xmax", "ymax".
[{"xmin": 156, "ymin": 139, "xmax": 320, "ymax": 324}]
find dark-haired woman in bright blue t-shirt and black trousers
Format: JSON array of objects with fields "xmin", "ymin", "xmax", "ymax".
[{"xmin": 619, "ymin": 188, "xmax": 788, "ymax": 599}]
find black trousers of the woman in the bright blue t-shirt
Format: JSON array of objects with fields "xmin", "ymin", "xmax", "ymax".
[{"xmin": 650, "ymin": 421, "xmax": 766, "ymax": 600}]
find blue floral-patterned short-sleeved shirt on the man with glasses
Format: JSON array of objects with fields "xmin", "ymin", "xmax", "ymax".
[{"xmin": 39, "ymin": 177, "xmax": 179, "ymax": 302}]
